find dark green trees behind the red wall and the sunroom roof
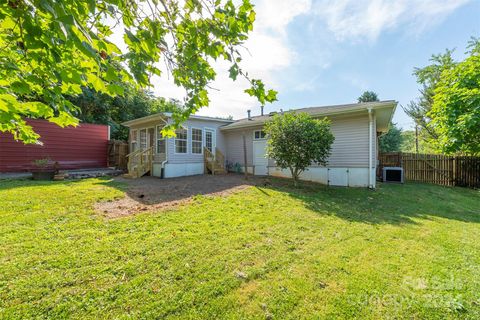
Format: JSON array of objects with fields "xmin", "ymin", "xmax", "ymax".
[{"xmin": 68, "ymin": 85, "xmax": 182, "ymax": 140}]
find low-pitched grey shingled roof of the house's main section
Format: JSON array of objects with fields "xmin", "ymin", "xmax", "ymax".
[{"xmin": 221, "ymin": 100, "xmax": 397, "ymax": 130}]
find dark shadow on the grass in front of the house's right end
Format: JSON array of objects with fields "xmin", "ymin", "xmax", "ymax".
[{"xmin": 271, "ymin": 183, "xmax": 480, "ymax": 225}]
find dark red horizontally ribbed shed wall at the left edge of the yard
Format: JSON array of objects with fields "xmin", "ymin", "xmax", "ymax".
[{"xmin": 0, "ymin": 120, "xmax": 109, "ymax": 172}]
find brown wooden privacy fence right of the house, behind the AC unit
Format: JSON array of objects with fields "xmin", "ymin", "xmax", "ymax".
[{"xmin": 378, "ymin": 152, "xmax": 480, "ymax": 188}]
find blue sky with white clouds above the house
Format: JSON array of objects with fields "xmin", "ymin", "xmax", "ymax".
[{"xmin": 145, "ymin": 0, "xmax": 480, "ymax": 129}]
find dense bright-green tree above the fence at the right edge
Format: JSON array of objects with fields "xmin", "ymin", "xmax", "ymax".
[{"xmin": 428, "ymin": 39, "xmax": 480, "ymax": 155}]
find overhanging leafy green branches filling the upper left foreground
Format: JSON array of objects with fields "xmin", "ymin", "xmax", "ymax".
[{"xmin": 0, "ymin": 0, "xmax": 276, "ymax": 142}]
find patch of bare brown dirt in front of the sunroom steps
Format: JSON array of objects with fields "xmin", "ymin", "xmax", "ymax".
[{"xmin": 95, "ymin": 174, "xmax": 270, "ymax": 218}]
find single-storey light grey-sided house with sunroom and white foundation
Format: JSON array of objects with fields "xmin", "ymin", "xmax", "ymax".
[{"xmin": 123, "ymin": 100, "xmax": 397, "ymax": 188}]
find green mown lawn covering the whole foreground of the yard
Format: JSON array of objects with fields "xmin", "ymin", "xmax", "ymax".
[{"xmin": 0, "ymin": 179, "xmax": 480, "ymax": 319}]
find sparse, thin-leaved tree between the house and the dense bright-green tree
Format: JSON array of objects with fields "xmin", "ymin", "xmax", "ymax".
[{"xmin": 402, "ymin": 49, "xmax": 455, "ymax": 141}]
